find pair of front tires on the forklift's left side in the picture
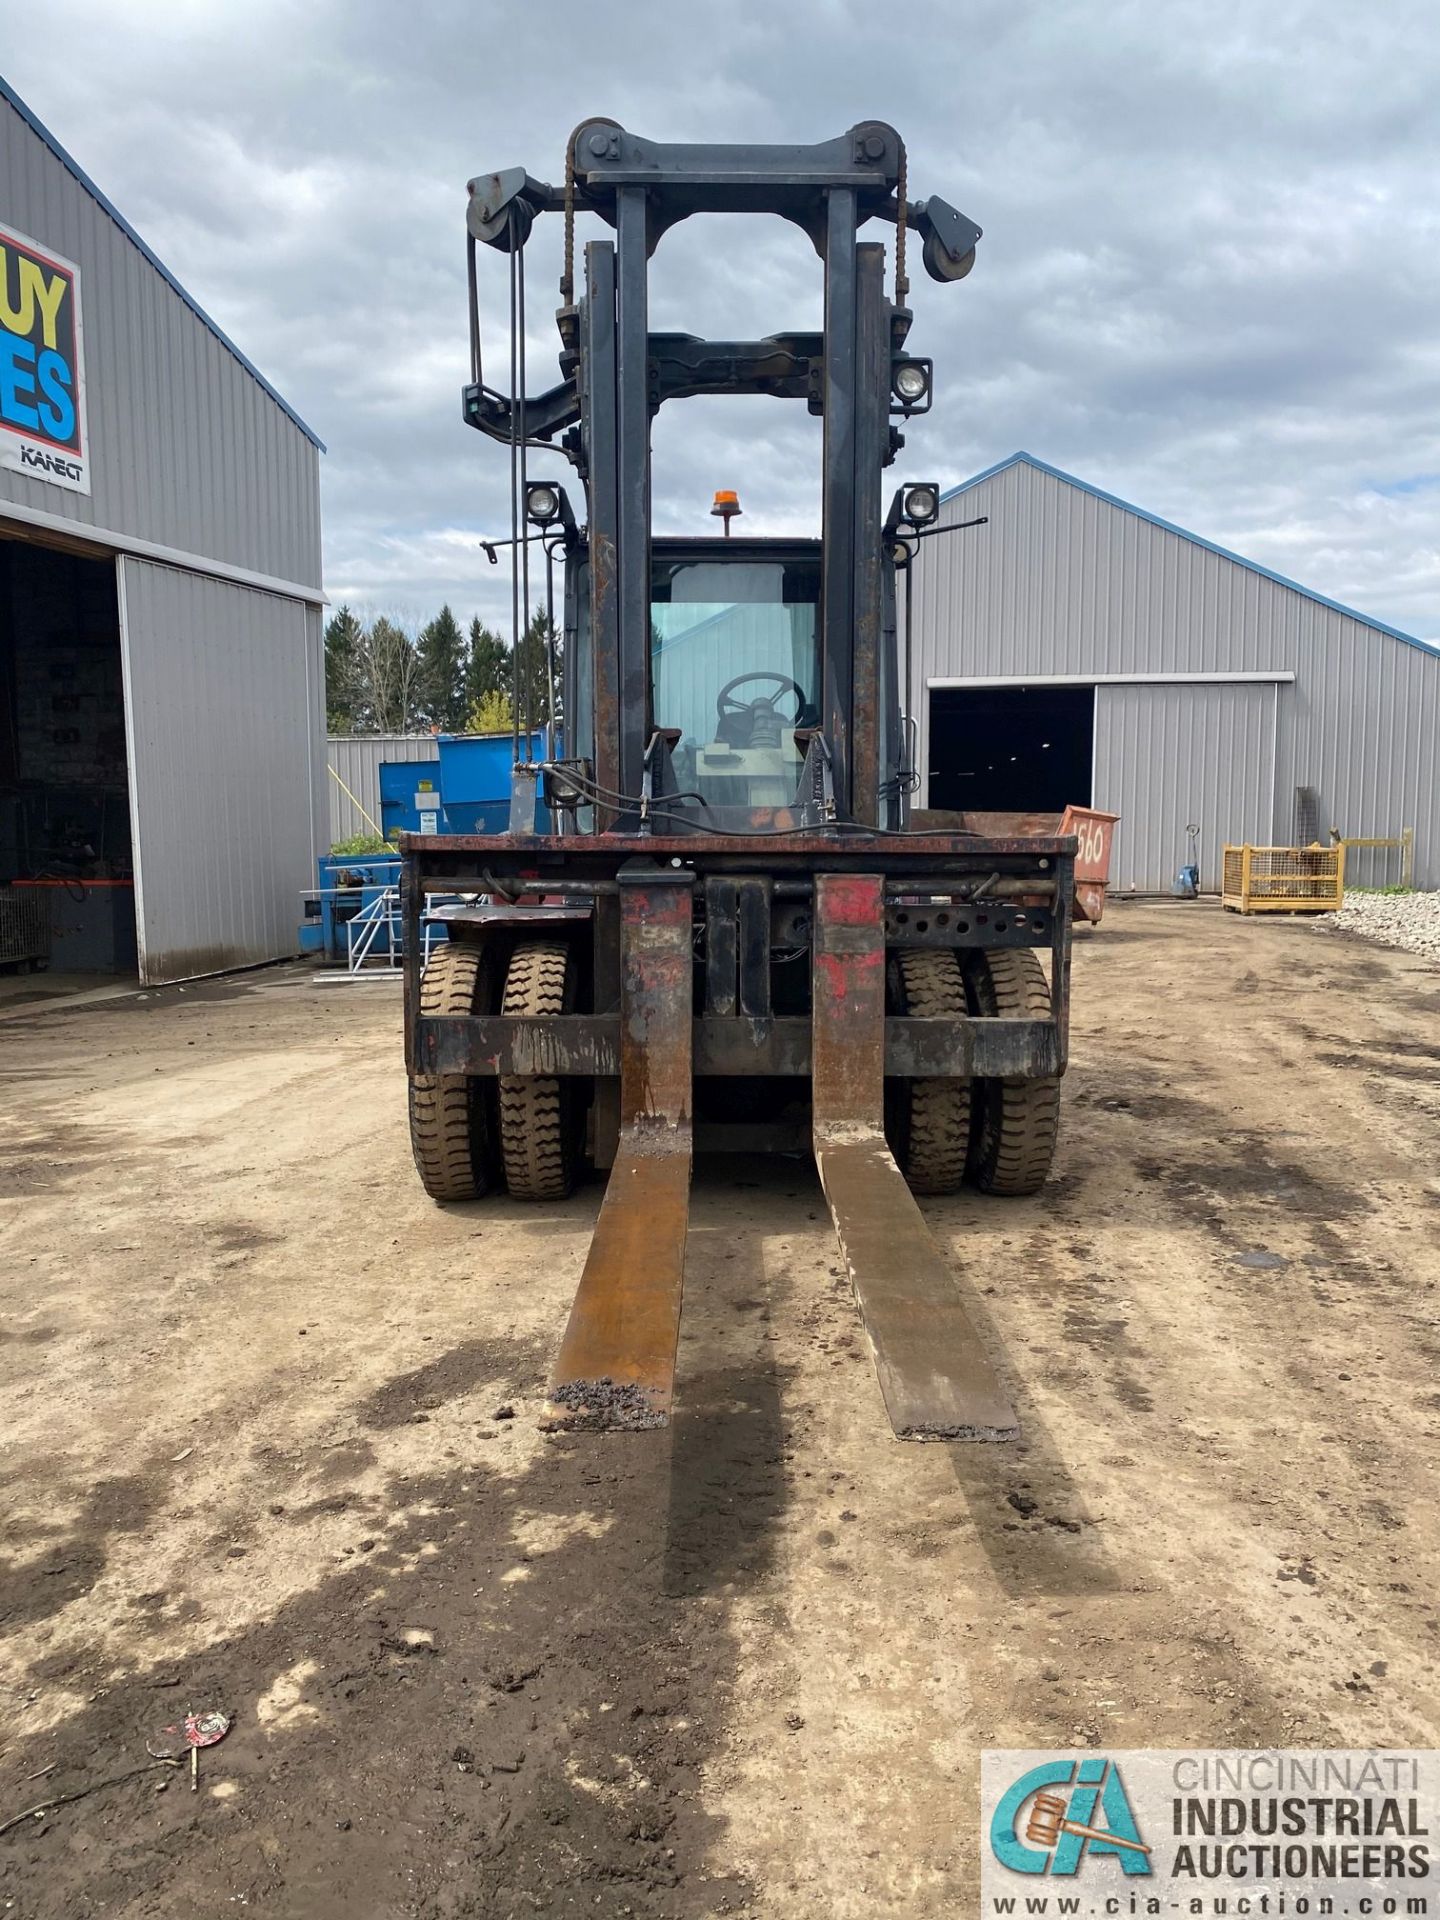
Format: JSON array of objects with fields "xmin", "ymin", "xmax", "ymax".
[{"xmin": 411, "ymin": 941, "xmax": 580, "ymax": 1200}]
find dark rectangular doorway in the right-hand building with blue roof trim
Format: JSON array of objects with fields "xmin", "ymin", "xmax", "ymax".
[{"xmin": 929, "ymin": 687, "xmax": 1094, "ymax": 814}]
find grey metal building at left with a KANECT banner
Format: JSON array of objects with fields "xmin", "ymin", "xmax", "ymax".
[{"xmin": 0, "ymin": 83, "xmax": 328, "ymax": 981}]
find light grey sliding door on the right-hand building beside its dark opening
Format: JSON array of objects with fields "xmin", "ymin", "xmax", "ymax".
[{"xmin": 1094, "ymin": 682, "xmax": 1279, "ymax": 893}]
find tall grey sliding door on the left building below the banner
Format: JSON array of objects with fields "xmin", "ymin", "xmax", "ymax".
[{"xmin": 119, "ymin": 555, "xmax": 324, "ymax": 981}]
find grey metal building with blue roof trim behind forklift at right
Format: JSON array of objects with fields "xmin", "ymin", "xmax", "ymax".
[{"xmin": 910, "ymin": 453, "xmax": 1440, "ymax": 893}]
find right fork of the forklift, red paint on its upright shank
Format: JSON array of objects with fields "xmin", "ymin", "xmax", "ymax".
[{"xmin": 812, "ymin": 874, "xmax": 1020, "ymax": 1440}]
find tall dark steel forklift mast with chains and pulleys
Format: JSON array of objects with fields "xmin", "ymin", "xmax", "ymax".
[{"xmin": 465, "ymin": 119, "xmax": 979, "ymax": 829}]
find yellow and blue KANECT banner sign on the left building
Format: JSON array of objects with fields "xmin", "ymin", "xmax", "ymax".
[{"xmin": 0, "ymin": 227, "xmax": 90, "ymax": 493}]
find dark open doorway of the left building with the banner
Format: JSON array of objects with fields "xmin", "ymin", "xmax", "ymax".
[{"xmin": 0, "ymin": 538, "xmax": 136, "ymax": 975}]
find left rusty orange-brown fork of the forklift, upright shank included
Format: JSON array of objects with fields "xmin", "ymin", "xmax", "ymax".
[{"xmin": 551, "ymin": 874, "xmax": 691, "ymax": 1430}]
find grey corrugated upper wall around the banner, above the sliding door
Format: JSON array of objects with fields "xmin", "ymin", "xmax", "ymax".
[{"xmin": 0, "ymin": 100, "xmax": 321, "ymax": 588}]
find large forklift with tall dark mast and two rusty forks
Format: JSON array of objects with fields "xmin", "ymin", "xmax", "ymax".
[{"xmin": 401, "ymin": 119, "xmax": 1075, "ymax": 1440}]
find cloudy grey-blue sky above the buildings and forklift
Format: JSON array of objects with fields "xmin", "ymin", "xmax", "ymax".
[{"xmin": 0, "ymin": 0, "xmax": 1440, "ymax": 637}]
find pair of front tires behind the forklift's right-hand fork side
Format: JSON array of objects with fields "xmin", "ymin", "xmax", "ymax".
[{"xmin": 887, "ymin": 947, "xmax": 1060, "ymax": 1196}]
